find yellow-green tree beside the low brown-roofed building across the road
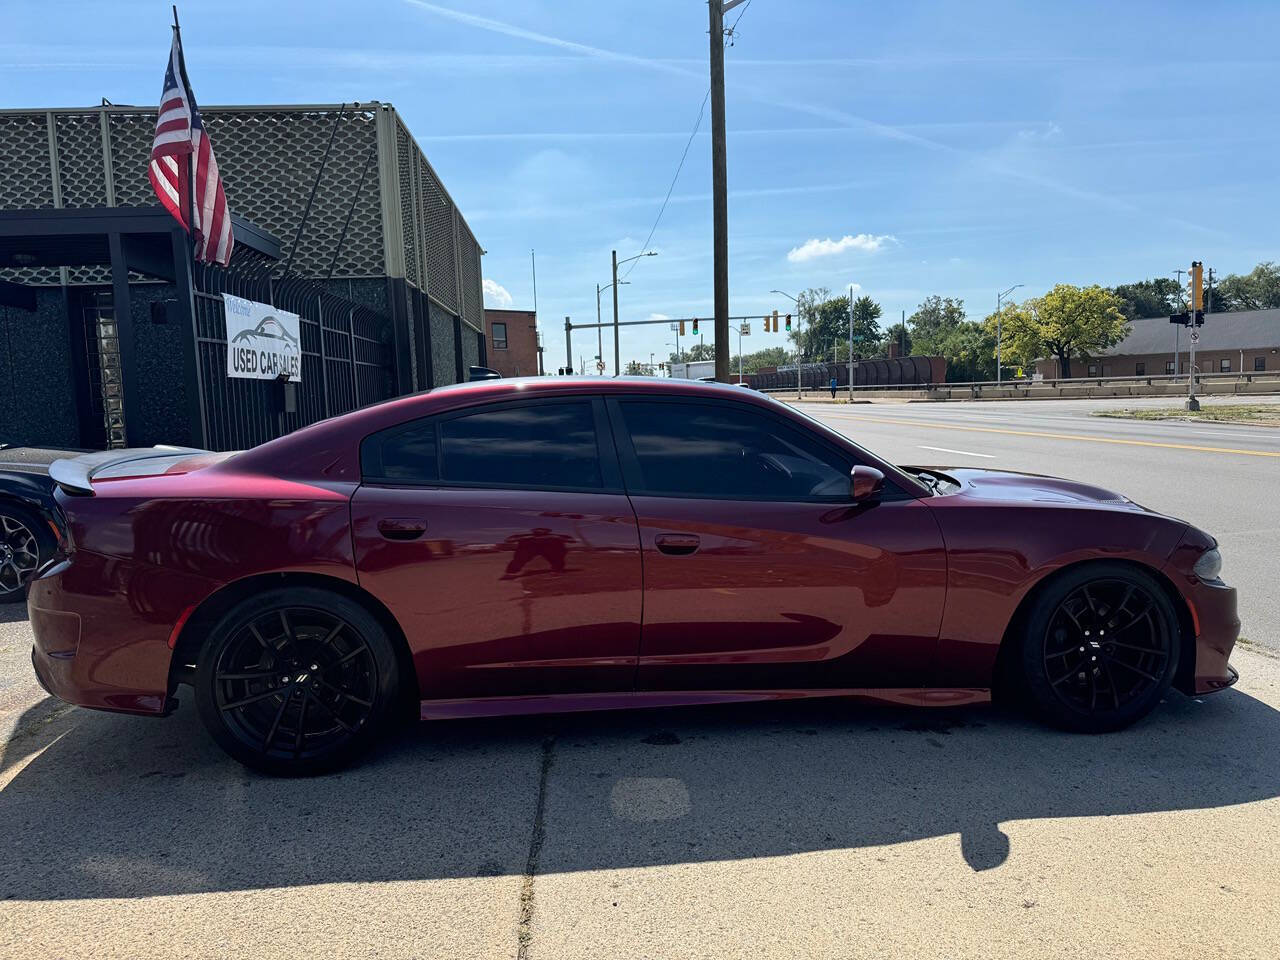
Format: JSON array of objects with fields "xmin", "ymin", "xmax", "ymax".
[{"xmin": 984, "ymin": 283, "xmax": 1129, "ymax": 378}]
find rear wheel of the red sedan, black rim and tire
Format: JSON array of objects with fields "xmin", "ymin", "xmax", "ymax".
[{"xmin": 195, "ymin": 586, "xmax": 399, "ymax": 777}]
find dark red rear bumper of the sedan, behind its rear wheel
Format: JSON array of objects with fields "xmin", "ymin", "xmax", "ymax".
[{"xmin": 27, "ymin": 550, "xmax": 203, "ymax": 716}]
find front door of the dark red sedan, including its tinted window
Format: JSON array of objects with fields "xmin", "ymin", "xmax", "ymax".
[{"xmin": 611, "ymin": 398, "xmax": 946, "ymax": 690}]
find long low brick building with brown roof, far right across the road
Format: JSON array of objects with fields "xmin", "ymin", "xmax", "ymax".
[{"xmin": 1036, "ymin": 310, "xmax": 1280, "ymax": 380}]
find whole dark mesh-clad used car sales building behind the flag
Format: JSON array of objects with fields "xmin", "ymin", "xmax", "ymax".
[{"xmin": 0, "ymin": 102, "xmax": 488, "ymax": 449}]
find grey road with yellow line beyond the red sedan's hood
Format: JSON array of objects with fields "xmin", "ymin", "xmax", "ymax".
[{"xmin": 796, "ymin": 397, "xmax": 1280, "ymax": 652}]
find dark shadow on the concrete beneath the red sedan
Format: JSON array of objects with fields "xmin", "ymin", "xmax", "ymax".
[{"xmin": 0, "ymin": 690, "xmax": 1280, "ymax": 901}]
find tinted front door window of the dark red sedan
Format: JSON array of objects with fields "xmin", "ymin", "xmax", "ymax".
[{"xmin": 618, "ymin": 401, "xmax": 852, "ymax": 500}]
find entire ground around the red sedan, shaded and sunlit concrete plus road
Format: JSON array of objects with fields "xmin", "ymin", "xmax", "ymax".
[{"xmin": 0, "ymin": 394, "xmax": 1280, "ymax": 960}]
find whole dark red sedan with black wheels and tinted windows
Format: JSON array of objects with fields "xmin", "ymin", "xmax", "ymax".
[{"xmin": 29, "ymin": 379, "xmax": 1239, "ymax": 773}]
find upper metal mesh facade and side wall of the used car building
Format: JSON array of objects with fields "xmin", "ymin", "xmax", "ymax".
[{"xmin": 0, "ymin": 102, "xmax": 486, "ymax": 392}]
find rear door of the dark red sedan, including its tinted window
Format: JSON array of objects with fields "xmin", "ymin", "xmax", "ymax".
[{"xmin": 352, "ymin": 397, "xmax": 641, "ymax": 699}]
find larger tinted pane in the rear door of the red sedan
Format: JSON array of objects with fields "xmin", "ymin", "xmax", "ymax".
[{"xmin": 439, "ymin": 399, "xmax": 603, "ymax": 488}]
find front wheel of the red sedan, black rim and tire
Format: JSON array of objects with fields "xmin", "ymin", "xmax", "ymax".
[{"xmin": 1018, "ymin": 562, "xmax": 1181, "ymax": 733}]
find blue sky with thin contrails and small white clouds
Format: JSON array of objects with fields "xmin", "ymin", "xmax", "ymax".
[{"xmin": 0, "ymin": 0, "xmax": 1280, "ymax": 365}]
